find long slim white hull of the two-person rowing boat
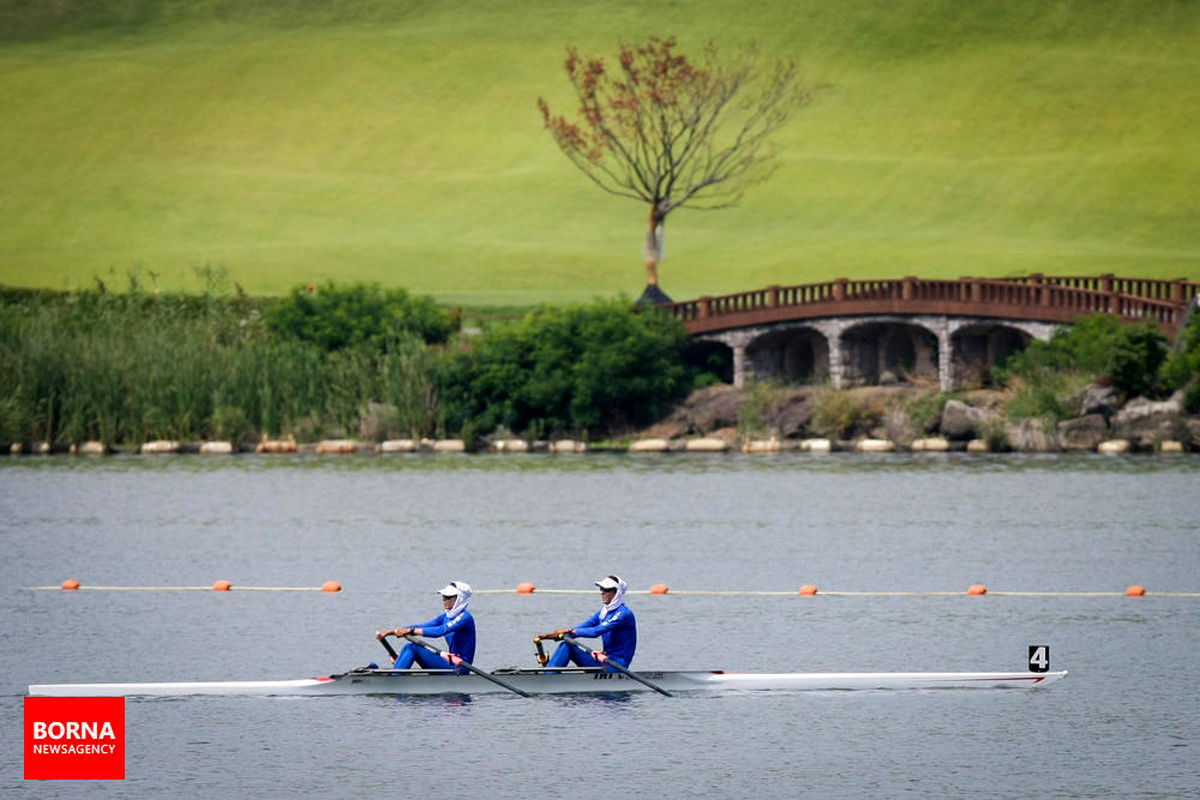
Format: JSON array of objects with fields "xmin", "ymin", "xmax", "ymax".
[{"xmin": 29, "ymin": 669, "xmax": 1067, "ymax": 697}]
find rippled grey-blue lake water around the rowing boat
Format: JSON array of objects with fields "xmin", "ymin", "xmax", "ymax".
[{"xmin": 0, "ymin": 453, "xmax": 1200, "ymax": 800}]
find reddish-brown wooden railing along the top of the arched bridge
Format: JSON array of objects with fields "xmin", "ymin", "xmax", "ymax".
[{"xmin": 661, "ymin": 275, "xmax": 1200, "ymax": 336}]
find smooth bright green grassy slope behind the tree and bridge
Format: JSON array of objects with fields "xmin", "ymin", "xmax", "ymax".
[{"xmin": 0, "ymin": 0, "xmax": 1200, "ymax": 306}]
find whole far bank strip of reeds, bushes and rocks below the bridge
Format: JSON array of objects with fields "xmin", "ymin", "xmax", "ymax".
[{"xmin": 0, "ymin": 276, "xmax": 1200, "ymax": 453}]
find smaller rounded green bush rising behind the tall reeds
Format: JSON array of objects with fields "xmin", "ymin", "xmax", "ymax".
[{"xmin": 266, "ymin": 282, "xmax": 457, "ymax": 353}]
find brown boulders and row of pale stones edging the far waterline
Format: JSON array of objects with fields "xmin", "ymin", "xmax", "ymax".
[{"xmin": 11, "ymin": 385, "xmax": 1200, "ymax": 456}]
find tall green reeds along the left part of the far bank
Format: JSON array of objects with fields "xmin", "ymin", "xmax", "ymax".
[{"xmin": 0, "ymin": 290, "xmax": 436, "ymax": 445}]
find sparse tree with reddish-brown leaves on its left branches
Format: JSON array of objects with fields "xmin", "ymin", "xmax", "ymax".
[{"xmin": 538, "ymin": 36, "xmax": 809, "ymax": 294}]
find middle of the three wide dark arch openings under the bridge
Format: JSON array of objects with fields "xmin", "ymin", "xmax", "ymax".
[{"xmin": 841, "ymin": 320, "xmax": 938, "ymax": 386}]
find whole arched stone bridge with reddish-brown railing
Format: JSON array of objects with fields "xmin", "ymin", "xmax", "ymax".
[{"xmin": 660, "ymin": 275, "xmax": 1200, "ymax": 391}]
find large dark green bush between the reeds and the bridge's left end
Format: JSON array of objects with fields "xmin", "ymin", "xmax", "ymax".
[{"xmin": 440, "ymin": 300, "xmax": 692, "ymax": 437}]
